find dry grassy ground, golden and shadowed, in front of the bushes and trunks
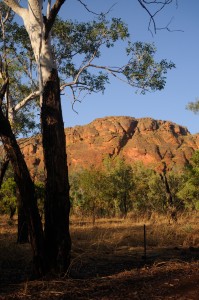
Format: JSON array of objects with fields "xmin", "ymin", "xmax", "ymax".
[{"xmin": 0, "ymin": 214, "xmax": 199, "ymax": 300}]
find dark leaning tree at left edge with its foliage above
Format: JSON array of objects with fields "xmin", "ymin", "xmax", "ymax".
[{"xmin": 0, "ymin": 3, "xmax": 45, "ymax": 274}]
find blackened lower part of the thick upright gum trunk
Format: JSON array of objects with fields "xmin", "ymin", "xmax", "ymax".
[{"xmin": 41, "ymin": 69, "xmax": 71, "ymax": 272}]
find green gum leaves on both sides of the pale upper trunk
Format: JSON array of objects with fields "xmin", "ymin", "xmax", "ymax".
[{"xmin": 0, "ymin": 2, "xmax": 174, "ymax": 135}]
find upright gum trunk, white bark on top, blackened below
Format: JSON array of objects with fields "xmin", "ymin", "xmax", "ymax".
[{"xmin": 4, "ymin": 0, "xmax": 71, "ymax": 272}]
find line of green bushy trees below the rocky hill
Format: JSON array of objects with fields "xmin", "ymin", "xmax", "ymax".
[{"xmin": 0, "ymin": 151, "xmax": 199, "ymax": 222}]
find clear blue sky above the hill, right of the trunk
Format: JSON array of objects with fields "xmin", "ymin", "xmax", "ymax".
[{"xmin": 61, "ymin": 0, "xmax": 199, "ymax": 133}]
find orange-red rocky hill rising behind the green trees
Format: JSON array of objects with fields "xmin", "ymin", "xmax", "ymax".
[{"xmin": 17, "ymin": 117, "xmax": 199, "ymax": 177}]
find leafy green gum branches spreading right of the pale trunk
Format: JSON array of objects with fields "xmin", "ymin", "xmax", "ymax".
[{"xmin": 52, "ymin": 15, "xmax": 175, "ymax": 99}]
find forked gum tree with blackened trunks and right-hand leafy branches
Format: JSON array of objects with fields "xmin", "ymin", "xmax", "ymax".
[{"xmin": 0, "ymin": 0, "xmax": 174, "ymax": 271}]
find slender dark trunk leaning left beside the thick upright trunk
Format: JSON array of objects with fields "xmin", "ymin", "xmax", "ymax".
[{"xmin": 0, "ymin": 109, "xmax": 45, "ymax": 275}]
